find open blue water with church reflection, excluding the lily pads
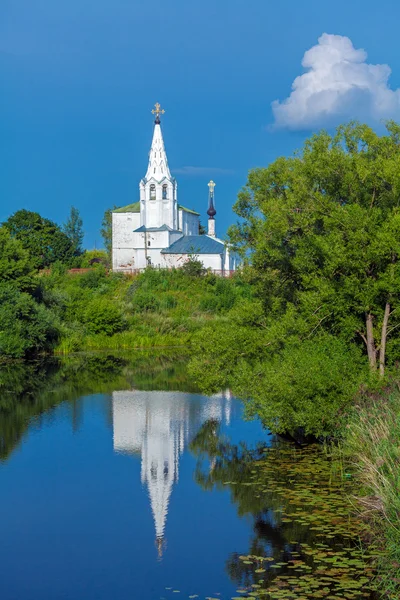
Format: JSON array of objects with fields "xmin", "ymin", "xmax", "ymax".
[{"xmin": 0, "ymin": 356, "xmax": 268, "ymax": 600}]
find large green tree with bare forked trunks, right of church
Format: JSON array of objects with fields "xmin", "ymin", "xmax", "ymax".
[{"xmin": 230, "ymin": 122, "xmax": 400, "ymax": 375}]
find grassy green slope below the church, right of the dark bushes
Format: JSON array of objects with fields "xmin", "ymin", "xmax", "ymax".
[{"xmin": 42, "ymin": 267, "xmax": 251, "ymax": 354}]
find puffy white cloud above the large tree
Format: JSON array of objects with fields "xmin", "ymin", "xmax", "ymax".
[{"xmin": 272, "ymin": 33, "xmax": 400, "ymax": 129}]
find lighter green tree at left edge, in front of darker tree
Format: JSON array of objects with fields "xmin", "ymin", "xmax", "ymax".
[{"xmin": 0, "ymin": 227, "xmax": 35, "ymax": 291}]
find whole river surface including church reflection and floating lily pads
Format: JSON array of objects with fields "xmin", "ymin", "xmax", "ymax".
[{"xmin": 0, "ymin": 353, "xmax": 373, "ymax": 600}]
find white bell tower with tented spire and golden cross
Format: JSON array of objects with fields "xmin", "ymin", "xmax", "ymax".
[{"xmin": 139, "ymin": 102, "xmax": 178, "ymax": 229}]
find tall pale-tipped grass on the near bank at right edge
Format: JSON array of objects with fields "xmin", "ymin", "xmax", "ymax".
[{"xmin": 343, "ymin": 389, "xmax": 400, "ymax": 600}]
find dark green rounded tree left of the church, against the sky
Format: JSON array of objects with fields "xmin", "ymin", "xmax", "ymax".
[{"xmin": 3, "ymin": 210, "xmax": 74, "ymax": 269}]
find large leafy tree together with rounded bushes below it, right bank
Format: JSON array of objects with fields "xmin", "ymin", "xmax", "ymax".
[{"xmin": 192, "ymin": 123, "xmax": 400, "ymax": 435}]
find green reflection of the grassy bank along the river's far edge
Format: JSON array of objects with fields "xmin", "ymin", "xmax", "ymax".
[{"xmin": 0, "ymin": 352, "xmax": 197, "ymax": 460}]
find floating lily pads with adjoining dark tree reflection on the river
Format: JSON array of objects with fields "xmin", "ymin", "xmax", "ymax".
[{"xmin": 191, "ymin": 423, "xmax": 381, "ymax": 600}]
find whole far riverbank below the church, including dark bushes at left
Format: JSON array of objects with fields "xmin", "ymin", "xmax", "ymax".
[{"xmin": 0, "ymin": 261, "xmax": 252, "ymax": 358}]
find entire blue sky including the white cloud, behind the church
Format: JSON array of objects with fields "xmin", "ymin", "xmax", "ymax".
[{"xmin": 0, "ymin": 0, "xmax": 400, "ymax": 248}]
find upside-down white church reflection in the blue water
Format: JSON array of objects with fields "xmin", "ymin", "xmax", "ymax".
[{"xmin": 112, "ymin": 390, "xmax": 232, "ymax": 556}]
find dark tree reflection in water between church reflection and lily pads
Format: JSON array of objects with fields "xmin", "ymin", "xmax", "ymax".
[{"xmin": 190, "ymin": 420, "xmax": 328, "ymax": 587}]
